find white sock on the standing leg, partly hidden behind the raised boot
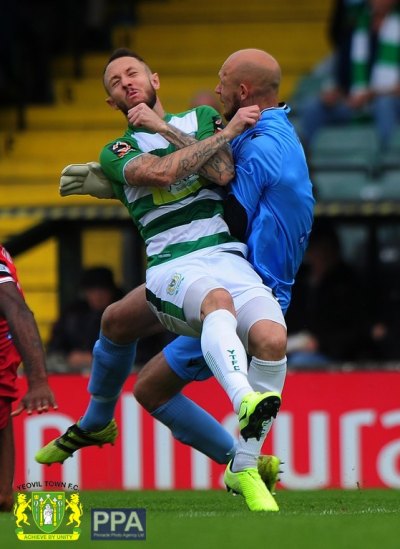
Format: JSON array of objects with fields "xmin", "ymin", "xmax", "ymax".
[{"xmin": 232, "ymin": 357, "xmax": 287, "ymax": 473}]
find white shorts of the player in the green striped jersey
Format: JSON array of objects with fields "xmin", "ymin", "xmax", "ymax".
[{"xmin": 146, "ymin": 248, "xmax": 286, "ymax": 340}]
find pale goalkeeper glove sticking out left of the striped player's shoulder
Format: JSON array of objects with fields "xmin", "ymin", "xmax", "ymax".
[{"xmin": 59, "ymin": 162, "xmax": 115, "ymax": 198}]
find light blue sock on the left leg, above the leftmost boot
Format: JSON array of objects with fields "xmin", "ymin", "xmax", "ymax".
[{"xmin": 79, "ymin": 333, "xmax": 137, "ymax": 431}]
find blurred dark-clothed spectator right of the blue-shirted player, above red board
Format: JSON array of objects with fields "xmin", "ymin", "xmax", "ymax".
[{"xmin": 286, "ymin": 222, "xmax": 369, "ymax": 366}]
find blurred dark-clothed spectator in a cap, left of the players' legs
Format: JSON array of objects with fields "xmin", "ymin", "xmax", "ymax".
[{"xmin": 47, "ymin": 266, "xmax": 123, "ymax": 372}]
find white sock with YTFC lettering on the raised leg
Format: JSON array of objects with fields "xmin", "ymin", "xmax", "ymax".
[{"xmin": 201, "ymin": 309, "xmax": 253, "ymax": 413}]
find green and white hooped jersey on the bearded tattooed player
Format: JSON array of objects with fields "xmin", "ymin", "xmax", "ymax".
[{"xmin": 100, "ymin": 106, "xmax": 246, "ymax": 267}]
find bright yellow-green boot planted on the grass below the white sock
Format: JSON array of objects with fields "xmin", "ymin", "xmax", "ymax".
[{"xmin": 224, "ymin": 462, "xmax": 279, "ymax": 512}]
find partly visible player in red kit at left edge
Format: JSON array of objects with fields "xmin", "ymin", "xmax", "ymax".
[{"xmin": 0, "ymin": 244, "xmax": 57, "ymax": 511}]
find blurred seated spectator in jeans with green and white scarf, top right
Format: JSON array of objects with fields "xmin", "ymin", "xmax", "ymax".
[{"xmin": 301, "ymin": 0, "xmax": 400, "ymax": 150}]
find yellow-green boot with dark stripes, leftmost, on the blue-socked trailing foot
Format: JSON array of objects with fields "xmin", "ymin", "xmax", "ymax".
[{"xmin": 35, "ymin": 419, "xmax": 118, "ymax": 465}]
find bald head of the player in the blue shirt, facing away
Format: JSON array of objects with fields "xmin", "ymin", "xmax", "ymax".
[{"xmin": 221, "ymin": 48, "xmax": 281, "ymax": 103}]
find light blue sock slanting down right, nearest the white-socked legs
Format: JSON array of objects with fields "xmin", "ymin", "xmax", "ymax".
[{"xmin": 151, "ymin": 394, "xmax": 235, "ymax": 463}]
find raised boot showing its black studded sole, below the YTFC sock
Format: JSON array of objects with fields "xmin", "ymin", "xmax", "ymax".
[{"xmin": 239, "ymin": 392, "xmax": 281, "ymax": 440}]
